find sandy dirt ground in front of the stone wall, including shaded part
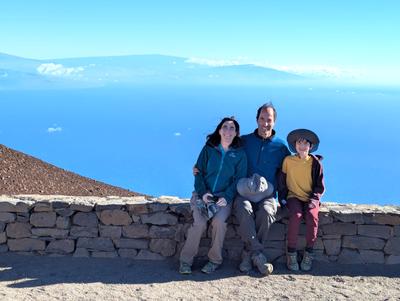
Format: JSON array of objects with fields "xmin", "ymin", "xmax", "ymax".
[{"xmin": 0, "ymin": 254, "xmax": 400, "ymax": 301}]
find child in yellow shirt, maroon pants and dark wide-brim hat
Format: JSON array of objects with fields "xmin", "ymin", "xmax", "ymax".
[{"xmin": 278, "ymin": 129, "xmax": 325, "ymax": 271}]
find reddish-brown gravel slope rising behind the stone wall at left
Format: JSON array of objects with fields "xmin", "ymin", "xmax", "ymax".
[{"xmin": 0, "ymin": 144, "xmax": 141, "ymax": 196}]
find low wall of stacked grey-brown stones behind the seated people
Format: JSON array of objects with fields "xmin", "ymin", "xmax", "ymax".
[{"xmin": 0, "ymin": 195, "xmax": 400, "ymax": 264}]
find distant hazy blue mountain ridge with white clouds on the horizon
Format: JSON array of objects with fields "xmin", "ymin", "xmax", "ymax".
[{"xmin": 0, "ymin": 53, "xmax": 306, "ymax": 90}]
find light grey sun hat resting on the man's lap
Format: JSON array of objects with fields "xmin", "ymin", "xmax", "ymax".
[{"xmin": 236, "ymin": 173, "xmax": 274, "ymax": 203}]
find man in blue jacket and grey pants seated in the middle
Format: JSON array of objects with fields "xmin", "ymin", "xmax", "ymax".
[{"xmin": 234, "ymin": 103, "xmax": 290, "ymax": 275}]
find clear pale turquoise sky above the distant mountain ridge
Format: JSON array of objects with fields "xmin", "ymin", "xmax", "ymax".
[{"xmin": 0, "ymin": 0, "xmax": 400, "ymax": 84}]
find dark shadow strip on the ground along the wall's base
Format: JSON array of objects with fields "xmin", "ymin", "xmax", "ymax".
[{"xmin": 0, "ymin": 254, "xmax": 400, "ymax": 288}]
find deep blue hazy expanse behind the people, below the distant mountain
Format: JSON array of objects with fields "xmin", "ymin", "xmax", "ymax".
[{"xmin": 0, "ymin": 85, "xmax": 400, "ymax": 205}]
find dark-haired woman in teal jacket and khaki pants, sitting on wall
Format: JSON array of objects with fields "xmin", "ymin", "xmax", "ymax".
[{"xmin": 179, "ymin": 117, "xmax": 247, "ymax": 274}]
